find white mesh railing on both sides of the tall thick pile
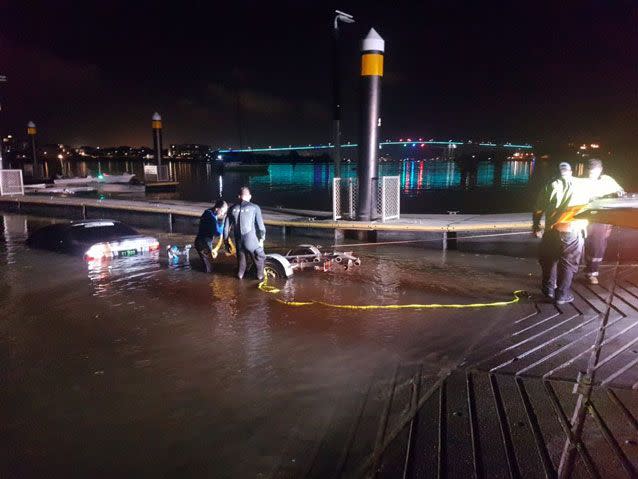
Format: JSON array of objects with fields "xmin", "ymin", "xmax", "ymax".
[{"xmin": 332, "ymin": 176, "xmax": 401, "ymax": 221}]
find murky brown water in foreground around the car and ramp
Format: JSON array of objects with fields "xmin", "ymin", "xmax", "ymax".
[{"xmin": 0, "ymin": 214, "xmax": 552, "ymax": 477}]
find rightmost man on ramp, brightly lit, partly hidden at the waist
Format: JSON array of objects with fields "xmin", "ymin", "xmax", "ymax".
[{"xmin": 585, "ymin": 158, "xmax": 625, "ymax": 284}]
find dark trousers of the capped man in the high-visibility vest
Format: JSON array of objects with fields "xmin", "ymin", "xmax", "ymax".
[{"xmin": 539, "ymin": 230, "xmax": 584, "ymax": 299}]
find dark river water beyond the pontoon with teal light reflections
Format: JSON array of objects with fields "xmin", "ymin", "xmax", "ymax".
[{"xmin": 32, "ymin": 157, "xmax": 534, "ymax": 213}]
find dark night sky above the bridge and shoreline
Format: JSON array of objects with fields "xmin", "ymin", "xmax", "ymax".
[{"xmin": 0, "ymin": 0, "xmax": 638, "ymax": 151}]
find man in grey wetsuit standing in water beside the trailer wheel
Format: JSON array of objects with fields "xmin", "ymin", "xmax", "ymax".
[{"xmin": 224, "ymin": 186, "xmax": 266, "ymax": 281}]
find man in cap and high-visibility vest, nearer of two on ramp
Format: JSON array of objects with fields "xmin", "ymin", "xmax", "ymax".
[{"xmin": 532, "ymin": 163, "xmax": 590, "ymax": 304}]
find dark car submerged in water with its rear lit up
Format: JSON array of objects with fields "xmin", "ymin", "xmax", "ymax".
[{"xmin": 27, "ymin": 220, "xmax": 159, "ymax": 261}]
